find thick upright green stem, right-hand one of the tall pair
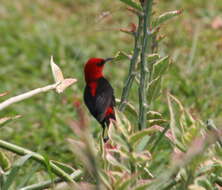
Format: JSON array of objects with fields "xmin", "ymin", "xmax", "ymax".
[{"xmin": 139, "ymin": 0, "xmax": 153, "ymax": 130}]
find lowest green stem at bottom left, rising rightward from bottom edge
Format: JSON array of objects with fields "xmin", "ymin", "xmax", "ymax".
[{"xmin": 19, "ymin": 170, "xmax": 82, "ymax": 190}]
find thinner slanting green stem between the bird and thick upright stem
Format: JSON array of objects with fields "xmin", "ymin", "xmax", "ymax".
[{"xmin": 119, "ymin": 15, "xmax": 143, "ymax": 111}]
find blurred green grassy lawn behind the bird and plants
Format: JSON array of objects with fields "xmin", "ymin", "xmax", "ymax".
[{"xmin": 0, "ymin": 0, "xmax": 222, "ymax": 171}]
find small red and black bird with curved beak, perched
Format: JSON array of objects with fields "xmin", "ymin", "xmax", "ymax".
[{"xmin": 84, "ymin": 58, "xmax": 116, "ymax": 142}]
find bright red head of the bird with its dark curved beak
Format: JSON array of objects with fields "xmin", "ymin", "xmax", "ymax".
[{"xmin": 84, "ymin": 58, "xmax": 112, "ymax": 83}]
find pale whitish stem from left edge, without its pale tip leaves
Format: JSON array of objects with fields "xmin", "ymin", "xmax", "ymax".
[{"xmin": 0, "ymin": 83, "xmax": 60, "ymax": 111}]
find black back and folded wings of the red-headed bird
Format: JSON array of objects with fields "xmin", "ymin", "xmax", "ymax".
[{"xmin": 84, "ymin": 77, "xmax": 115, "ymax": 123}]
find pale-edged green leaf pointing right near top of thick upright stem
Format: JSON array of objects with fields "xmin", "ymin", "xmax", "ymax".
[{"xmin": 153, "ymin": 10, "xmax": 182, "ymax": 27}]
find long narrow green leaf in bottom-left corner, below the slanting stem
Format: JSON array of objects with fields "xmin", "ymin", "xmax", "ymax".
[{"xmin": 2, "ymin": 154, "xmax": 32, "ymax": 190}]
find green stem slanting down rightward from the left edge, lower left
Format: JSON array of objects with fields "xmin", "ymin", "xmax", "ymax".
[{"xmin": 0, "ymin": 140, "xmax": 75, "ymax": 183}]
